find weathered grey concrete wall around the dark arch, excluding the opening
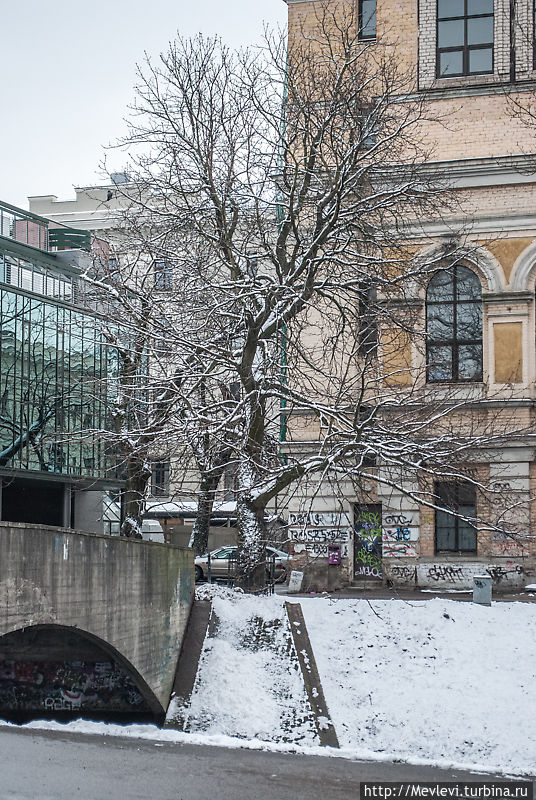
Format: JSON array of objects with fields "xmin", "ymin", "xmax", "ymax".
[{"xmin": 0, "ymin": 522, "xmax": 194, "ymax": 713}]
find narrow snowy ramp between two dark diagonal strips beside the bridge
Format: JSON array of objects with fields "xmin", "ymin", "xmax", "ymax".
[{"xmin": 168, "ymin": 589, "xmax": 319, "ymax": 745}]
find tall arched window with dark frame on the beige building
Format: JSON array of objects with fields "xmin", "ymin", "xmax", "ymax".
[{"xmin": 426, "ymin": 266, "xmax": 482, "ymax": 382}]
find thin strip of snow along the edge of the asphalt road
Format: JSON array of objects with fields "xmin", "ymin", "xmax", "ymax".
[{"xmin": 0, "ymin": 719, "xmax": 533, "ymax": 778}]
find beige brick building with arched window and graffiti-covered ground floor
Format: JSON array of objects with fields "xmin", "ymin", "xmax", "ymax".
[{"xmin": 280, "ymin": 0, "xmax": 536, "ymax": 590}]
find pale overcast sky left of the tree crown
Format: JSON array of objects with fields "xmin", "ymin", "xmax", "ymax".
[{"xmin": 0, "ymin": 0, "xmax": 287, "ymax": 208}]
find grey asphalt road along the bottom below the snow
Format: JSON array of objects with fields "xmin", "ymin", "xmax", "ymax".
[{"xmin": 0, "ymin": 728, "xmax": 524, "ymax": 800}]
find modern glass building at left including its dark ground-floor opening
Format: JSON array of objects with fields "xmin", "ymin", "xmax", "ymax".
[{"xmin": 0, "ymin": 197, "xmax": 117, "ymax": 531}]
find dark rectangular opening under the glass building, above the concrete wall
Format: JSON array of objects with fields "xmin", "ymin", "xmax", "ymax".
[{"xmin": 2, "ymin": 478, "xmax": 65, "ymax": 527}]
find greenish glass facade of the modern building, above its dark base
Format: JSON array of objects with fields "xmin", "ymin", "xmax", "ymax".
[{"xmin": 0, "ymin": 216, "xmax": 118, "ymax": 479}]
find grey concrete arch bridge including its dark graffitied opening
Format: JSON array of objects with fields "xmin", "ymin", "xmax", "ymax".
[{"xmin": 0, "ymin": 522, "xmax": 194, "ymax": 720}]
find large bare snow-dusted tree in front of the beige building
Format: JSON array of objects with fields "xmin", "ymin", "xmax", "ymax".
[{"xmin": 88, "ymin": 4, "xmax": 528, "ymax": 586}]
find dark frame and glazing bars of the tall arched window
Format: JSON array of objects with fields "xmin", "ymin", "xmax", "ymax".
[{"xmin": 426, "ymin": 264, "xmax": 484, "ymax": 383}]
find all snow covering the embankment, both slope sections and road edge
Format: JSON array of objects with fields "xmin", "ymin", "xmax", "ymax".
[{"xmin": 2, "ymin": 587, "xmax": 536, "ymax": 776}]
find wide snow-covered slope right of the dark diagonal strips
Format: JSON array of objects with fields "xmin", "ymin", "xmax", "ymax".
[{"xmin": 301, "ymin": 598, "xmax": 536, "ymax": 775}]
